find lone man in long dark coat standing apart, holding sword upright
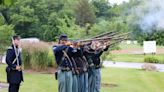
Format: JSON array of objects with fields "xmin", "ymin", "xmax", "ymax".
[{"xmin": 6, "ymin": 35, "xmax": 23, "ymax": 92}]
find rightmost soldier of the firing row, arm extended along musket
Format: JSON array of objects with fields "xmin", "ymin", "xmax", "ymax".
[{"xmin": 84, "ymin": 41, "xmax": 108, "ymax": 92}]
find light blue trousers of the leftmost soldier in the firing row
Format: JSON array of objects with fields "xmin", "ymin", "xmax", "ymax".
[{"xmin": 58, "ymin": 70, "xmax": 73, "ymax": 92}]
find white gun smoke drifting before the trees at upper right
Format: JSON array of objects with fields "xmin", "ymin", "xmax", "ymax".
[{"xmin": 136, "ymin": 0, "xmax": 164, "ymax": 32}]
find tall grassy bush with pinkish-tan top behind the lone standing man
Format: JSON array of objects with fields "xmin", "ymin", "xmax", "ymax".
[{"xmin": 22, "ymin": 42, "xmax": 55, "ymax": 71}]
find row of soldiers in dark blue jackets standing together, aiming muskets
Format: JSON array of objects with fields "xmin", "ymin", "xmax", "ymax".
[{"xmin": 53, "ymin": 35, "xmax": 108, "ymax": 92}]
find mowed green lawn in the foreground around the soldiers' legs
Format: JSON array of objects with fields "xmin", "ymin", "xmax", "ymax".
[{"xmin": 0, "ymin": 65, "xmax": 164, "ymax": 92}]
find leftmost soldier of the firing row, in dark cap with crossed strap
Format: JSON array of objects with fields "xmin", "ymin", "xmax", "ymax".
[{"xmin": 53, "ymin": 35, "xmax": 74, "ymax": 92}]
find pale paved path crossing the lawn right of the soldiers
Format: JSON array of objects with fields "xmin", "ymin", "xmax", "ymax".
[{"xmin": 103, "ymin": 61, "xmax": 164, "ymax": 72}]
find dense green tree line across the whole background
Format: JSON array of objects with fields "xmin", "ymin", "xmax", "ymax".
[{"xmin": 0, "ymin": 0, "xmax": 164, "ymax": 52}]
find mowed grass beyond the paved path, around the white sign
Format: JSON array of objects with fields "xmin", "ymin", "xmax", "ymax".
[{"xmin": 107, "ymin": 43, "xmax": 164, "ymax": 63}]
